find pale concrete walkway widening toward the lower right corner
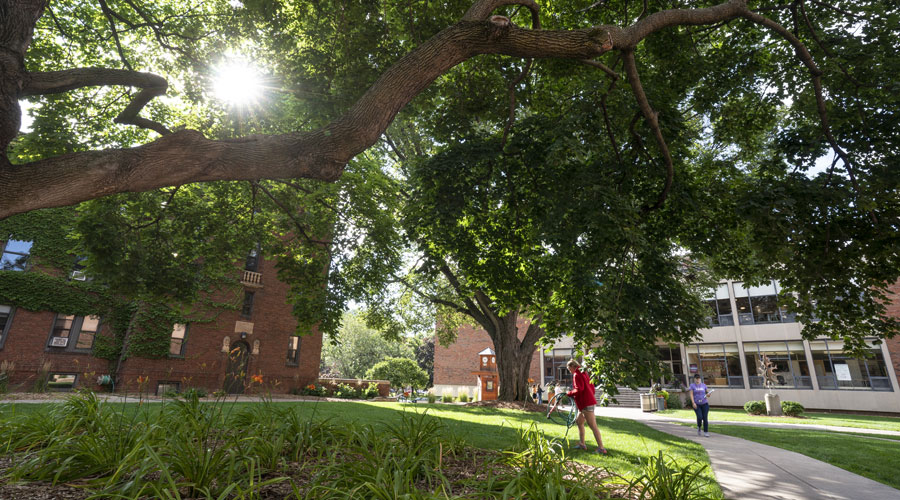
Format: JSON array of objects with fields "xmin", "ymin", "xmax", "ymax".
[{"xmin": 597, "ymin": 408, "xmax": 900, "ymax": 500}]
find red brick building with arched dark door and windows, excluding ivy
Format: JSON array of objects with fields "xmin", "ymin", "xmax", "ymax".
[{"xmin": 0, "ymin": 239, "xmax": 322, "ymax": 394}]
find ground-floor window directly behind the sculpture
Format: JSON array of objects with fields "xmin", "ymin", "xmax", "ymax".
[{"xmin": 744, "ymin": 340, "xmax": 812, "ymax": 389}]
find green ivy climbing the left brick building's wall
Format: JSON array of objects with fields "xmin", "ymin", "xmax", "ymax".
[{"xmin": 0, "ymin": 207, "xmax": 240, "ymax": 365}]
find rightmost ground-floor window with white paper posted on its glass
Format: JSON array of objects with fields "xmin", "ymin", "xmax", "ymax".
[{"xmin": 809, "ymin": 340, "xmax": 894, "ymax": 391}]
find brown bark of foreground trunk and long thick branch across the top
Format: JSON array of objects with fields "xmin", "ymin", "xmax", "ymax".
[{"xmin": 0, "ymin": 0, "xmax": 749, "ymax": 218}]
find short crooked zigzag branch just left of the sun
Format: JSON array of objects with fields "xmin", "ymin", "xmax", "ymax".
[{"xmin": 20, "ymin": 68, "xmax": 171, "ymax": 135}]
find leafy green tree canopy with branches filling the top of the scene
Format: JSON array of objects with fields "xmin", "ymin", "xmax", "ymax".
[{"xmin": 0, "ymin": 0, "xmax": 900, "ymax": 398}]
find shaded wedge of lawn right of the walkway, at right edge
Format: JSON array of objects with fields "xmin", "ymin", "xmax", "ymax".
[{"xmin": 711, "ymin": 425, "xmax": 900, "ymax": 490}]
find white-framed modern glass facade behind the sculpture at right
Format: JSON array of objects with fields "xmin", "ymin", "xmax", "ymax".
[{"xmin": 660, "ymin": 281, "xmax": 900, "ymax": 413}]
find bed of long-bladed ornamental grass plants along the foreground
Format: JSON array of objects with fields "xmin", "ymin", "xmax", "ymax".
[{"xmin": 0, "ymin": 392, "xmax": 716, "ymax": 500}]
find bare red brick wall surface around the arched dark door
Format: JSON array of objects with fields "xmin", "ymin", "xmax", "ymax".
[{"xmin": 0, "ymin": 260, "xmax": 322, "ymax": 393}]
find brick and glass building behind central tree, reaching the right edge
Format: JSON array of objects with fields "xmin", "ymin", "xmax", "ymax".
[{"xmin": 434, "ymin": 280, "xmax": 900, "ymax": 413}]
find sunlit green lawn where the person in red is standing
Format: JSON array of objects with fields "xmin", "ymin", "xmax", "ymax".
[{"xmin": 0, "ymin": 401, "xmax": 721, "ymax": 497}]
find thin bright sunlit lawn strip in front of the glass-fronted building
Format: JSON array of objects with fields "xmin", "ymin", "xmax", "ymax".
[{"xmin": 658, "ymin": 408, "xmax": 900, "ymax": 432}]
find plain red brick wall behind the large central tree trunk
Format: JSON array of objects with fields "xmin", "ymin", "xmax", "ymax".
[{"xmin": 434, "ymin": 319, "xmax": 541, "ymax": 385}]
